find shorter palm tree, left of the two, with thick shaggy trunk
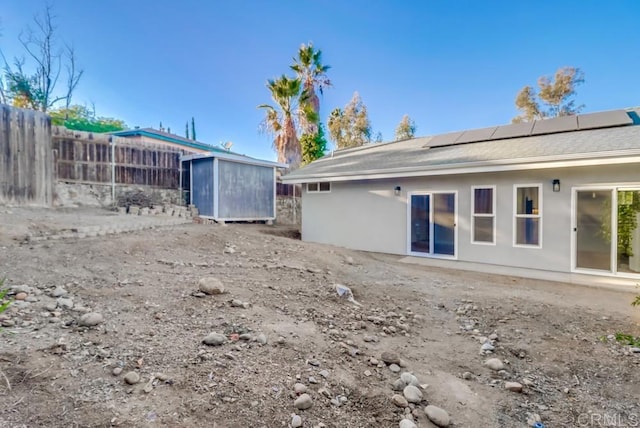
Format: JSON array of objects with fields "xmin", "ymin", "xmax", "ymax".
[{"xmin": 258, "ymin": 75, "xmax": 302, "ymax": 169}]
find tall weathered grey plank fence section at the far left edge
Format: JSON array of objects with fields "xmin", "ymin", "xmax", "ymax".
[{"xmin": 0, "ymin": 104, "xmax": 53, "ymax": 205}]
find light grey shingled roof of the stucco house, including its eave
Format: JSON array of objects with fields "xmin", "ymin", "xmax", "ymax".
[{"xmin": 282, "ymin": 110, "xmax": 640, "ymax": 183}]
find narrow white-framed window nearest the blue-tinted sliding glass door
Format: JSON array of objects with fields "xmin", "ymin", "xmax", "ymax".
[{"xmin": 471, "ymin": 186, "xmax": 496, "ymax": 244}]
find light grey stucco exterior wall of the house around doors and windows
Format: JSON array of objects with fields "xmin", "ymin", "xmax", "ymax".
[{"xmin": 302, "ymin": 164, "xmax": 640, "ymax": 272}]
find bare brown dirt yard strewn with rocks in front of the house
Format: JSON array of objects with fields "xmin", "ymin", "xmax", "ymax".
[{"xmin": 0, "ymin": 207, "xmax": 640, "ymax": 428}]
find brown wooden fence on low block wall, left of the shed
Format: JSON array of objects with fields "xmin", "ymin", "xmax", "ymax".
[{"xmin": 53, "ymin": 127, "xmax": 183, "ymax": 189}]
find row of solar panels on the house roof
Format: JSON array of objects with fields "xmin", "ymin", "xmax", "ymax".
[{"xmin": 424, "ymin": 110, "xmax": 634, "ymax": 148}]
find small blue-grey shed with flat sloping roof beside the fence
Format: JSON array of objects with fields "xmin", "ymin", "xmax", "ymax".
[{"xmin": 180, "ymin": 151, "xmax": 286, "ymax": 221}]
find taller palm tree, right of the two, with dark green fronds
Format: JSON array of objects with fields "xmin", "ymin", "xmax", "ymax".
[{"xmin": 291, "ymin": 43, "xmax": 331, "ymax": 134}]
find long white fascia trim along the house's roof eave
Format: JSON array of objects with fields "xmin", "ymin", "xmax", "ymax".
[{"xmin": 281, "ymin": 150, "xmax": 640, "ymax": 184}]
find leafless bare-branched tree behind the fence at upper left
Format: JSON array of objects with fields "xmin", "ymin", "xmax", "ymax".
[{"xmin": 6, "ymin": 5, "xmax": 84, "ymax": 112}]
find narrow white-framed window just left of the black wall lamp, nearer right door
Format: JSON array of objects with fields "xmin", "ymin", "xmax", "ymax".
[{"xmin": 514, "ymin": 184, "xmax": 542, "ymax": 247}]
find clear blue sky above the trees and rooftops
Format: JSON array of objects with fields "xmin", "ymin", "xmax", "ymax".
[{"xmin": 0, "ymin": 0, "xmax": 640, "ymax": 159}]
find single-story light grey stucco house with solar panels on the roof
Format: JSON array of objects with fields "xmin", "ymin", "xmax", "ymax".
[{"xmin": 283, "ymin": 109, "xmax": 640, "ymax": 284}]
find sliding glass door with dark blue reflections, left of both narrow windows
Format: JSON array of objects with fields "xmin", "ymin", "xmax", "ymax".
[{"xmin": 409, "ymin": 192, "xmax": 456, "ymax": 257}]
